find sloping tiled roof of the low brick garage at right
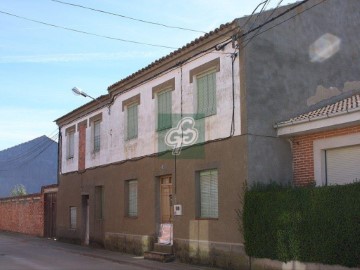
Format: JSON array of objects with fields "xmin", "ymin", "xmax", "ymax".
[{"xmin": 278, "ymin": 94, "xmax": 360, "ymax": 126}]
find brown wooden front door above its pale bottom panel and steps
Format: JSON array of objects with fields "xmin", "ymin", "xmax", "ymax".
[{"xmin": 160, "ymin": 176, "xmax": 173, "ymax": 223}]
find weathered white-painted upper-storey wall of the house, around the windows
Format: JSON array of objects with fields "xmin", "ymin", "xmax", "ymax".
[{"xmin": 61, "ymin": 44, "xmax": 241, "ymax": 173}]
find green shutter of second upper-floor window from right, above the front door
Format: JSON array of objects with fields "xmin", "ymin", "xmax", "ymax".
[{"xmin": 157, "ymin": 91, "xmax": 172, "ymax": 130}]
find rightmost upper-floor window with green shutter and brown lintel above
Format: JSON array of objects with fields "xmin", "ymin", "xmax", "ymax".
[{"xmin": 189, "ymin": 58, "xmax": 220, "ymax": 117}]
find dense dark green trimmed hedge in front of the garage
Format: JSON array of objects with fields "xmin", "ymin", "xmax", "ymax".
[{"xmin": 243, "ymin": 183, "xmax": 360, "ymax": 267}]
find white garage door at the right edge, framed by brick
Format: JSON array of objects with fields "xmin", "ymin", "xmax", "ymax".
[{"xmin": 326, "ymin": 145, "xmax": 360, "ymax": 185}]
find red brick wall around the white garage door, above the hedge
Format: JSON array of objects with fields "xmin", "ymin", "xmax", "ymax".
[{"xmin": 293, "ymin": 125, "xmax": 360, "ymax": 186}]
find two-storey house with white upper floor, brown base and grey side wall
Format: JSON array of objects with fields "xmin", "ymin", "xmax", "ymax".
[{"xmin": 56, "ymin": 0, "xmax": 360, "ymax": 266}]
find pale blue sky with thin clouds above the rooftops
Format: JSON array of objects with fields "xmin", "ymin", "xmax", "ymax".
[{"xmin": 0, "ymin": 0, "xmax": 295, "ymax": 150}]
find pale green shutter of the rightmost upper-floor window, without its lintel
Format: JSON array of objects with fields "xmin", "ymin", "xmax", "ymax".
[{"xmin": 196, "ymin": 72, "xmax": 216, "ymax": 116}]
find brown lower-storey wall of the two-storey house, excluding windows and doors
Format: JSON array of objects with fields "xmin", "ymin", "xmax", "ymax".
[{"xmin": 57, "ymin": 136, "xmax": 247, "ymax": 268}]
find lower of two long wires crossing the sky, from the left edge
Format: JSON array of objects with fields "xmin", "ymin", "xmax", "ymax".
[{"xmin": 0, "ymin": 10, "xmax": 178, "ymax": 49}]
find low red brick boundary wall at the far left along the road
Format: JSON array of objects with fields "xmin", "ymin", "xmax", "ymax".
[{"xmin": 0, "ymin": 194, "xmax": 44, "ymax": 236}]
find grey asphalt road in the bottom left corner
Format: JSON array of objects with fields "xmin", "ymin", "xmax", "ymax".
[{"xmin": 0, "ymin": 232, "xmax": 214, "ymax": 270}]
